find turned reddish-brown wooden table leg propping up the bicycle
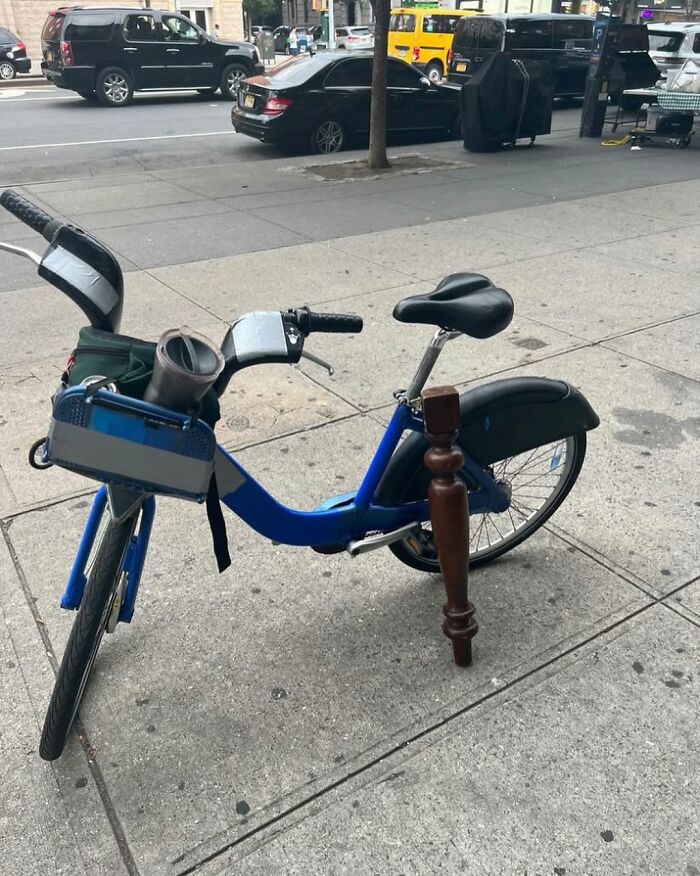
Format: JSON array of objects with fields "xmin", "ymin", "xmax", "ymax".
[{"xmin": 422, "ymin": 386, "xmax": 479, "ymax": 666}]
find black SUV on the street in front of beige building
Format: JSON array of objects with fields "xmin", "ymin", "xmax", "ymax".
[{"xmin": 41, "ymin": 6, "xmax": 265, "ymax": 106}]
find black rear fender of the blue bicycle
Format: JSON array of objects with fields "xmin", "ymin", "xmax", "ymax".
[{"xmin": 375, "ymin": 377, "xmax": 600, "ymax": 505}]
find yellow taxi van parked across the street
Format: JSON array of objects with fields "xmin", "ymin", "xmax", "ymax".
[{"xmin": 389, "ymin": 7, "xmax": 476, "ymax": 82}]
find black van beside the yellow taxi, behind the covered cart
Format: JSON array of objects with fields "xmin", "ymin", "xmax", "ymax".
[{"xmin": 447, "ymin": 13, "xmax": 594, "ymax": 97}]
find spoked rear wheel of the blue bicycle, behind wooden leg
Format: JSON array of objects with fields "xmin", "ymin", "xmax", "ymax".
[{"xmin": 389, "ymin": 432, "xmax": 586, "ymax": 572}]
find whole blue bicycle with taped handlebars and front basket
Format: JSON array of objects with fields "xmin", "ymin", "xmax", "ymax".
[{"xmin": 0, "ymin": 191, "xmax": 599, "ymax": 760}]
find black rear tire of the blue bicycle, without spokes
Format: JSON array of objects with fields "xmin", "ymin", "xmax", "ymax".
[{"xmin": 389, "ymin": 432, "xmax": 586, "ymax": 573}]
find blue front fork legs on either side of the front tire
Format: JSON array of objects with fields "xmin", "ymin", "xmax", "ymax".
[{"xmin": 61, "ymin": 484, "xmax": 156, "ymax": 623}]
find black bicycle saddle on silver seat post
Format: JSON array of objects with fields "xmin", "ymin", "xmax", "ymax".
[{"xmin": 394, "ymin": 273, "xmax": 513, "ymax": 338}]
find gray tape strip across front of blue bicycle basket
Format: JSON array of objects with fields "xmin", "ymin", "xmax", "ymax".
[{"xmin": 49, "ymin": 420, "xmax": 214, "ymax": 496}]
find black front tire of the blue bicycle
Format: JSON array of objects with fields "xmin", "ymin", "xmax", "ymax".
[{"xmin": 39, "ymin": 514, "xmax": 138, "ymax": 760}]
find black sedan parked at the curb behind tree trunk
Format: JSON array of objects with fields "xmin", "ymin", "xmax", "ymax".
[{"xmin": 231, "ymin": 52, "xmax": 459, "ymax": 153}]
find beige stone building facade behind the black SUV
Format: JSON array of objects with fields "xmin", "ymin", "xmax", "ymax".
[{"xmin": 0, "ymin": 0, "xmax": 243, "ymax": 69}]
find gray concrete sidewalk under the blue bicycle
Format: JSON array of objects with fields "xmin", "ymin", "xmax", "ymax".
[{"xmin": 0, "ymin": 128, "xmax": 700, "ymax": 876}]
